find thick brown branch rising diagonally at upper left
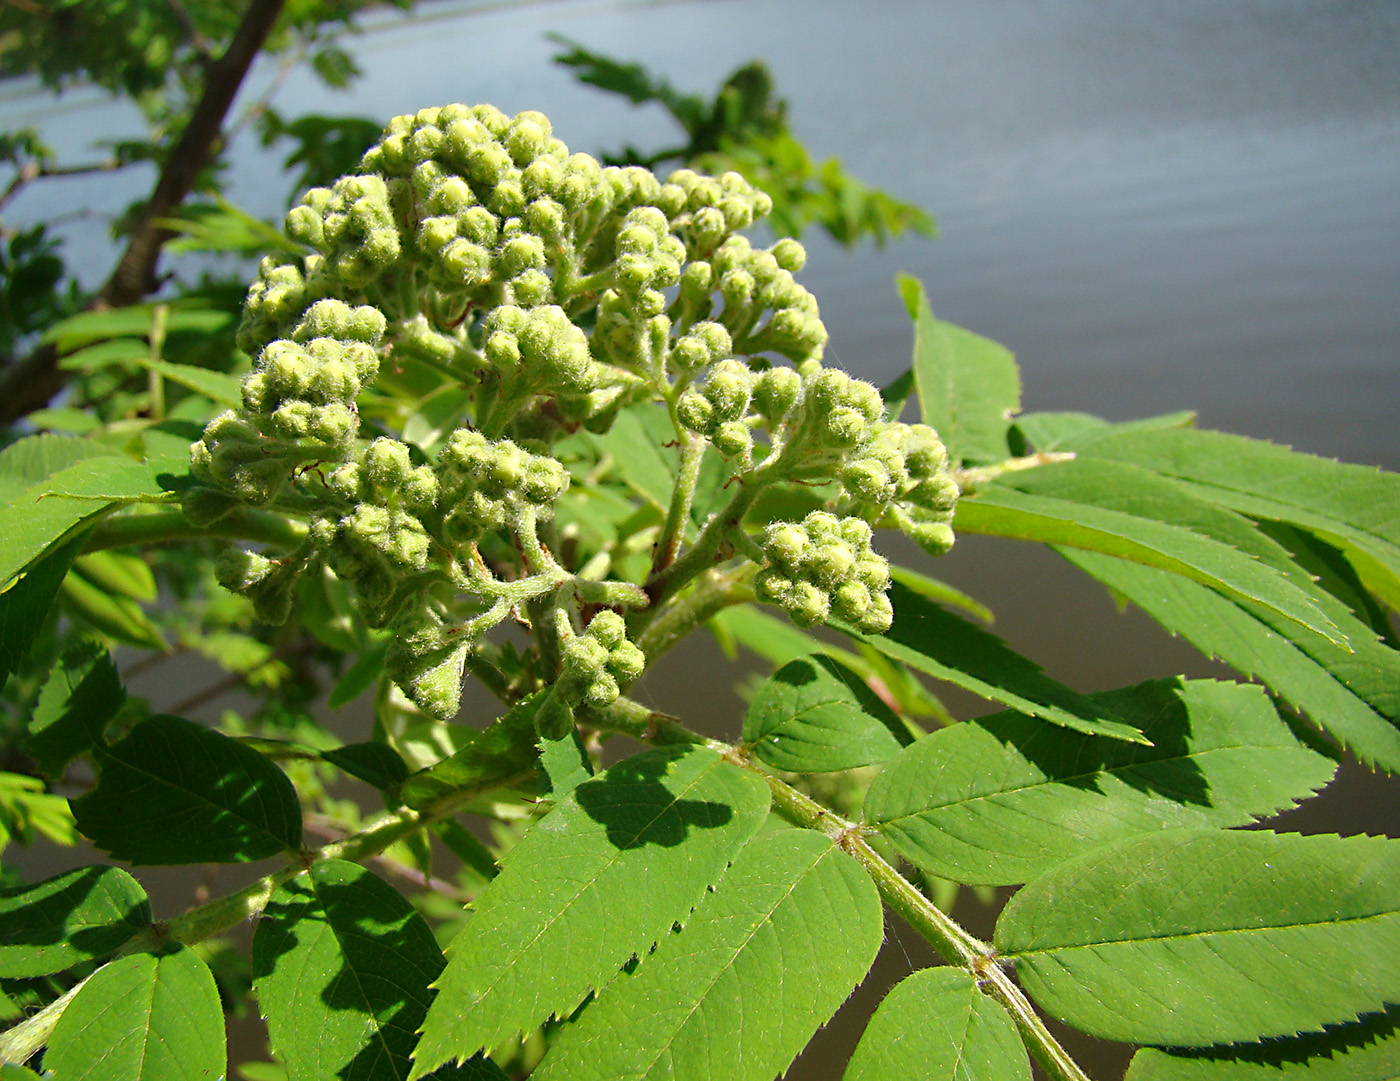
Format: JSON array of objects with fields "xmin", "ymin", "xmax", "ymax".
[{"xmin": 0, "ymin": 0, "xmax": 286, "ymax": 424}]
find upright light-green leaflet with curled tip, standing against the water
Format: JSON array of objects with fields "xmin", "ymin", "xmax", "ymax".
[{"xmin": 897, "ymin": 274, "xmax": 1021, "ymax": 465}]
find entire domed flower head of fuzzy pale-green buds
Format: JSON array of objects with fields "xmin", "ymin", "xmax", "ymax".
[{"xmin": 194, "ymin": 105, "xmax": 958, "ymax": 731}]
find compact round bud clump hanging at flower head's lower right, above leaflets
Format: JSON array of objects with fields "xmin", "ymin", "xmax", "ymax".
[{"xmin": 753, "ymin": 511, "xmax": 893, "ymax": 634}]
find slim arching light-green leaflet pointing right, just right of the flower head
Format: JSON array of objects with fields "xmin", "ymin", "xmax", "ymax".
[{"xmin": 953, "ymin": 486, "xmax": 1345, "ymax": 643}]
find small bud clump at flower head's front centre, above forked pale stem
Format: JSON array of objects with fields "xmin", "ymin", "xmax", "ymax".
[{"xmin": 438, "ymin": 428, "xmax": 568, "ymax": 545}]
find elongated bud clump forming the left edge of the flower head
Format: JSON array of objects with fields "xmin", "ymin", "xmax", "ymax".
[{"xmin": 190, "ymin": 300, "xmax": 385, "ymax": 504}]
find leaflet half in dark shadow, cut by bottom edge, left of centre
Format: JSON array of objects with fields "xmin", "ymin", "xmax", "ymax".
[{"xmin": 252, "ymin": 860, "xmax": 444, "ymax": 1081}]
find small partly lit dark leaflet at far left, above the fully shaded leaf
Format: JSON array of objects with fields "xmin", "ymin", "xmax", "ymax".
[{"xmin": 25, "ymin": 641, "xmax": 126, "ymax": 777}]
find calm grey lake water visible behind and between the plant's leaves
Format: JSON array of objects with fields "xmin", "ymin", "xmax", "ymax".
[{"xmin": 8, "ymin": 0, "xmax": 1400, "ymax": 1078}]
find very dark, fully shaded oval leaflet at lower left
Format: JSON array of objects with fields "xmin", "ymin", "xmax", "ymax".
[{"xmin": 73, "ymin": 716, "xmax": 301, "ymax": 864}]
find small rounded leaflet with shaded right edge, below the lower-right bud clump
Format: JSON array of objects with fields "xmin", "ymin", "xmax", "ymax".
[{"xmin": 743, "ymin": 655, "xmax": 910, "ymax": 773}]
